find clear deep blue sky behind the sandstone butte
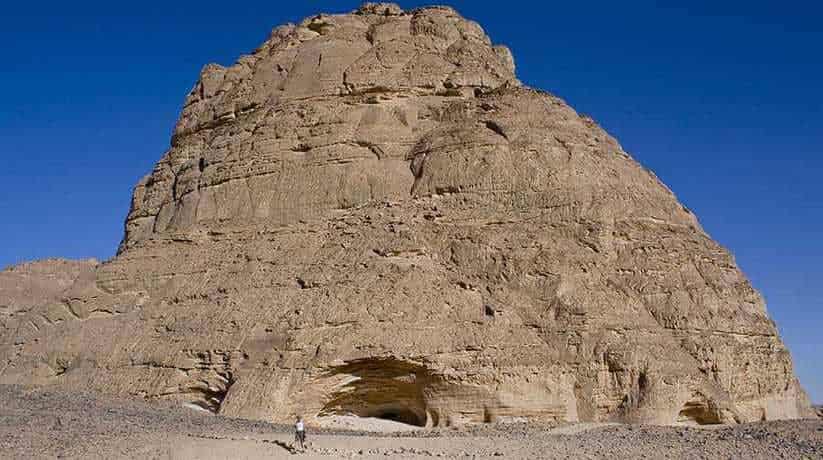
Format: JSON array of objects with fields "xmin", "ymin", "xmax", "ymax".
[{"xmin": 0, "ymin": 0, "xmax": 823, "ymax": 402}]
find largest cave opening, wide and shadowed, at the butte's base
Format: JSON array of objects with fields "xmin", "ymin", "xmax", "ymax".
[{"xmin": 318, "ymin": 358, "xmax": 436, "ymax": 427}]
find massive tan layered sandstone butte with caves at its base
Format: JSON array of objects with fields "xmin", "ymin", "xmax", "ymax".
[{"xmin": 0, "ymin": 4, "xmax": 813, "ymax": 426}]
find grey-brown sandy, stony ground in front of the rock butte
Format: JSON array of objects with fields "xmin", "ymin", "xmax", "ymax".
[{"xmin": 0, "ymin": 386, "xmax": 823, "ymax": 460}]
